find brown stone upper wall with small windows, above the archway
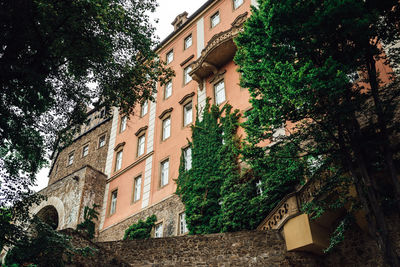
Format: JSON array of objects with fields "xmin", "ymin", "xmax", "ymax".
[{"xmin": 49, "ymin": 119, "xmax": 111, "ymax": 185}]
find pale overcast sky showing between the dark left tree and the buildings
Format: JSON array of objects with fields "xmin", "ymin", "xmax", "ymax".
[{"xmin": 32, "ymin": 0, "xmax": 207, "ymax": 191}]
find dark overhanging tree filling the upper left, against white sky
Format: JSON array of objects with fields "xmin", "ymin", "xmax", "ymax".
[{"xmin": 0, "ymin": 0, "xmax": 172, "ymax": 255}]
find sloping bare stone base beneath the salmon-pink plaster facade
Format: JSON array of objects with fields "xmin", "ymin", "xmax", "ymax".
[{"xmin": 97, "ymin": 195, "xmax": 185, "ymax": 241}]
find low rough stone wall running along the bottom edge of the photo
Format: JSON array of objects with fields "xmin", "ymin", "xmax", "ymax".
[{"xmin": 98, "ymin": 230, "xmax": 319, "ymax": 267}]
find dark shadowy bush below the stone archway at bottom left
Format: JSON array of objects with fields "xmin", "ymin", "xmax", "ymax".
[{"xmin": 5, "ymin": 218, "xmax": 76, "ymax": 267}]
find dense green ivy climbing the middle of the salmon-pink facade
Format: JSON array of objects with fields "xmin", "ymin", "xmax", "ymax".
[{"xmin": 176, "ymin": 99, "xmax": 265, "ymax": 234}]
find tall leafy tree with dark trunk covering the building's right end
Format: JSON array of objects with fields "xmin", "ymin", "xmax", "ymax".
[{"xmin": 235, "ymin": 0, "xmax": 400, "ymax": 266}]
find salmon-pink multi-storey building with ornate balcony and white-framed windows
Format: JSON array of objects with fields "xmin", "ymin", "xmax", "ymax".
[{"xmin": 99, "ymin": 0, "xmax": 256, "ymax": 241}]
